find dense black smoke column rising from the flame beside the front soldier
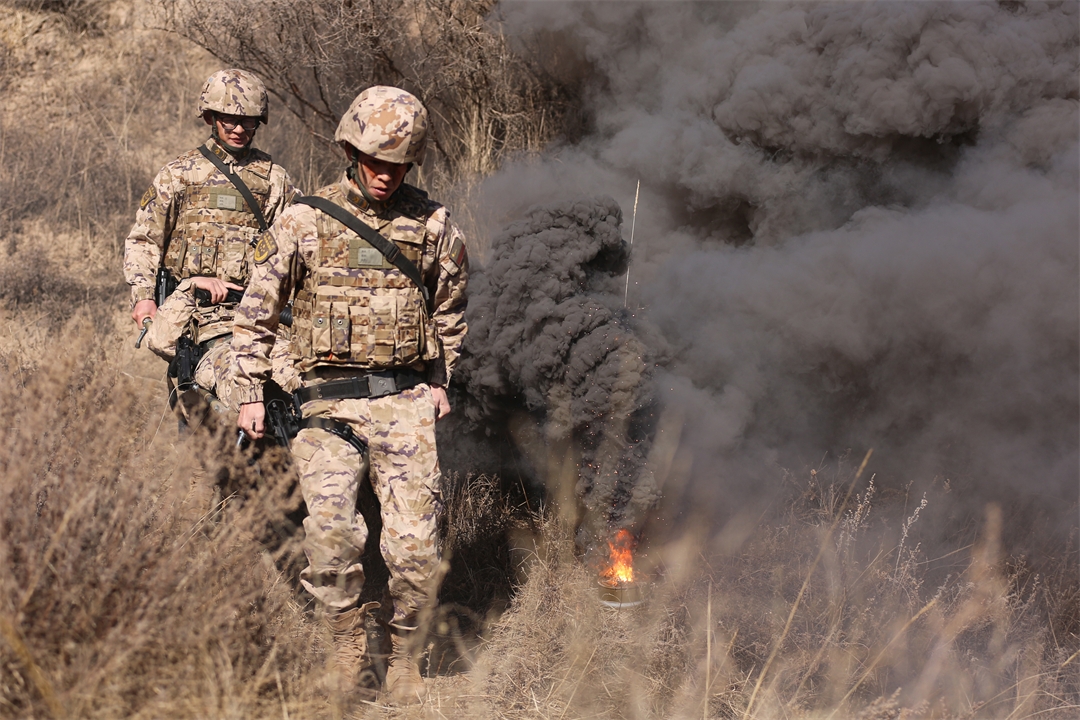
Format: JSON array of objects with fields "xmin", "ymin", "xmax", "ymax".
[{"xmin": 447, "ymin": 198, "xmax": 656, "ymax": 544}]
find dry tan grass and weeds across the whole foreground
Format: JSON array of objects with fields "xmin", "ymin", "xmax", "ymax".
[{"xmin": 0, "ymin": 330, "xmax": 1080, "ymax": 718}]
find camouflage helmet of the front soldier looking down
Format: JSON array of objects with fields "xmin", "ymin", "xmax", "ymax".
[{"xmin": 334, "ymin": 85, "xmax": 428, "ymax": 165}]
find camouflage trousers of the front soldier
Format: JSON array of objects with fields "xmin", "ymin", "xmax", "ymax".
[{"xmin": 292, "ymin": 384, "xmax": 442, "ymax": 628}]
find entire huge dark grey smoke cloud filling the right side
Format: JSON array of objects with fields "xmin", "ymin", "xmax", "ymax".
[{"xmin": 451, "ymin": 2, "xmax": 1080, "ymax": 552}]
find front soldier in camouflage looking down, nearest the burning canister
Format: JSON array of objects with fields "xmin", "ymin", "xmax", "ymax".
[{"xmin": 232, "ymin": 86, "xmax": 468, "ymax": 703}]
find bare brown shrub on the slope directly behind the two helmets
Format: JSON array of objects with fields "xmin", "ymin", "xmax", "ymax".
[{"xmin": 158, "ymin": 0, "xmax": 580, "ymax": 194}]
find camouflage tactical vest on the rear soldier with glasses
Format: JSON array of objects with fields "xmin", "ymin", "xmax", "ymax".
[{"xmin": 165, "ymin": 145, "xmax": 273, "ymax": 286}]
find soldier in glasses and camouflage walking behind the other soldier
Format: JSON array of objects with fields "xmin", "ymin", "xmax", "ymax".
[{"xmin": 124, "ymin": 70, "xmax": 299, "ymax": 422}]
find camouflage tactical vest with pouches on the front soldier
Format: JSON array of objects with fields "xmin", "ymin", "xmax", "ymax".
[{"xmin": 293, "ymin": 184, "xmax": 438, "ymax": 370}]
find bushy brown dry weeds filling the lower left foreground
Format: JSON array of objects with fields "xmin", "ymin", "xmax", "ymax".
[{"xmin": 0, "ymin": 320, "xmax": 328, "ymax": 718}]
